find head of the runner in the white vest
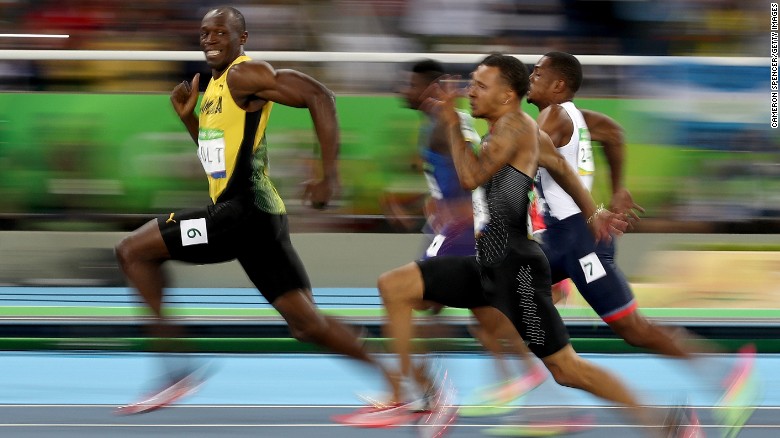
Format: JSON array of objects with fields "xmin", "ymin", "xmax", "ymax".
[{"xmin": 528, "ymin": 52, "xmax": 582, "ymax": 109}]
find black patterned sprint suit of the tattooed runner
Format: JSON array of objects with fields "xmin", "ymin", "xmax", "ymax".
[{"xmin": 417, "ymin": 134, "xmax": 569, "ymax": 357}]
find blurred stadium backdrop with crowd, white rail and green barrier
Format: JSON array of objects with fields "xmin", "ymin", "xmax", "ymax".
[{"xmin": 0, "ymin": 0, "xmax": 780, "ymax": 322}]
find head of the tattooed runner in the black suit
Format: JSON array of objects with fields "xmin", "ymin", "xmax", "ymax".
[{"xmin": 469, "ymin": 53, "xmax": 528, "ymax": 119}]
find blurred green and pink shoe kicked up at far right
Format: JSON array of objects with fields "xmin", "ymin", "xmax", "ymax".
[{"xmin": 714, "ymin": 344, "xmax": 760, "ymax": 438}]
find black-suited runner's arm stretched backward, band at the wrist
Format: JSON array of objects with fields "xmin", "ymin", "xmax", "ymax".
[{"xmin": 539, "ymin": 131, "xmax": 628, "ymax": 240}]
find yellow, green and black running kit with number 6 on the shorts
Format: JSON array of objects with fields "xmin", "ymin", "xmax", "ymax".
[{"xmin": 158, "ymin": 56, "xmax": 310, "ymax": 303}]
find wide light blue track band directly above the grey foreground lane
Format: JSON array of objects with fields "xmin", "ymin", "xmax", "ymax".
[{"xmin": 0, "ymin": 352, "xmax": 780, "ymax": 407}]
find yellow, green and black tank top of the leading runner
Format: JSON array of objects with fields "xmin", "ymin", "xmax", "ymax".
[{"xmin": 198, "ymin": 55, "xmax": 285, "ymax": 214}]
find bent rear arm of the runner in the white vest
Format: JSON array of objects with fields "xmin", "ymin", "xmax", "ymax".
[{"xmin": 580, "ymin": 110, "xmax": 645, "ymax": 221}]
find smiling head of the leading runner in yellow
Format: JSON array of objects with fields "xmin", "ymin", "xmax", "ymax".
[{"xmin": 200, "ymin": 6, "xmax": 248, "ymax": 74}]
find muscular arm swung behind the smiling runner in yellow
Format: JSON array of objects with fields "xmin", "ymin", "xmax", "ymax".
[{"xmin": 228, "ymin": 62, "xmax": 341, "ymax": 208}]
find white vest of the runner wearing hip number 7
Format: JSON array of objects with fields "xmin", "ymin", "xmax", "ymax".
[{"xmin": 536, "ymin": 102, "xmax": 595, "ymax": 220}]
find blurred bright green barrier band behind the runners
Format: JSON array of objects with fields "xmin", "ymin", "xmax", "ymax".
[{"xmin": 0, "ymin": 93, "xmax": 780, "ymax": 229}]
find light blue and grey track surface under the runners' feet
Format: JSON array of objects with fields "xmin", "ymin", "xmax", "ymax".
[{"xmin": 0, "ymin": 352, "xmax": 780, "ymax": 438}]
